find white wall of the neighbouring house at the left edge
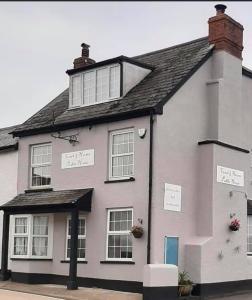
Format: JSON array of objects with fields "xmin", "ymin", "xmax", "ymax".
[{"xmin": 0, "ymin": 150, "xmax": 18, "ymax": 262}]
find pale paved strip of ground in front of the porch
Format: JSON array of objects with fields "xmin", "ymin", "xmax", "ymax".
[{"xmin": 0, "ymin": 280, "xmax": 142, "ymax": 300}]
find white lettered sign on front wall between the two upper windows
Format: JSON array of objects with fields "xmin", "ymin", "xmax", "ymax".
[{"xmin": 61, "ymin": 149, "xmax": 94, "ymax": 169}]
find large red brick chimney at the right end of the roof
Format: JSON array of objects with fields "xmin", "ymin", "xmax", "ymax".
[{"xmin": 208, "ymin": 4, "xmax": 243, "ymax": 59}]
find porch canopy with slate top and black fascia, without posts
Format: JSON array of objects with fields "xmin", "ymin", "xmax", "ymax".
[{"xmin": 0, "ymin": 188, "xmax": 93, "ymax": 214}]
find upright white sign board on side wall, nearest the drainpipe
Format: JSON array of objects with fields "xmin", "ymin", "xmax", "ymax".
[{"xmin": 164, "ymin": 183, "xmax": 181, "ymax": 211}]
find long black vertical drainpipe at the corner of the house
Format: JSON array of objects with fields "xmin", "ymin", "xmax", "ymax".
[{"xmin": 147, "ymin": 111, "xmax": 153, "ymax": 264}]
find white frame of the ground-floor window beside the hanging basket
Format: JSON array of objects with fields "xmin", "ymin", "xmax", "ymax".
[{"xmin": 106, "ymin": 207, "xmax": 134, "ymax": 261}]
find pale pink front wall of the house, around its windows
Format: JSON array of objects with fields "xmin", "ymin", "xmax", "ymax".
[{"xmin": 11, "ymin": 117, "xmax": 149, "ymax": 282}]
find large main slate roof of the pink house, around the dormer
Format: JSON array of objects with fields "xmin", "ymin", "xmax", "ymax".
[{"xmin": 14, "ymin": 37, "xmax": 213, "ymax": 136}]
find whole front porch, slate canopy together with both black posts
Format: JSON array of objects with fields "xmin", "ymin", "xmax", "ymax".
[{"xmin": 0, "ymin": 188, "xmax": 93, "ymax": 290}]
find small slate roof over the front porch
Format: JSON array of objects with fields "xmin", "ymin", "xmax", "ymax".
[{"xmin": 0, "ymin": 188, "xmax": 93, "ymax": 210}]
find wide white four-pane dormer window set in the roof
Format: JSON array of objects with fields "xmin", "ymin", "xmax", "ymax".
[{"xmin": 70, "ymin": 64, "xmax": 120, "ymax": 107}]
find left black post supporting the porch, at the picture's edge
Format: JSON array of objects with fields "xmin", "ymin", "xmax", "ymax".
[{"xmin": 0, "ymin": 212, "xmax": 10, "ymax": 281}]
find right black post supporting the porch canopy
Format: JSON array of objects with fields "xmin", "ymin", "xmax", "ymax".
[{"xmin": 67, "ymin": 207, "xmax": 79, "ymax": 290}]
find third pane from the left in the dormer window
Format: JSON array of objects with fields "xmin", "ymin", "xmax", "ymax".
[{"xmin": 96, "ymin": 68, "xmax": 109, "ymax": 102}]
